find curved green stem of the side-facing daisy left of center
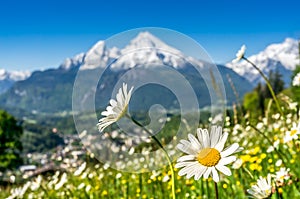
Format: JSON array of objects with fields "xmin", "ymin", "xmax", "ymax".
[{"xmin": 125, "ymin": 114, "xmax": 176, "ymax": 199}]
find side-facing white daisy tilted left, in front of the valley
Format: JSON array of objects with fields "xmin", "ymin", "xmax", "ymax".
[{"xmin": 97, "ymin": 83, "xmax": 133, "ymax": 131}]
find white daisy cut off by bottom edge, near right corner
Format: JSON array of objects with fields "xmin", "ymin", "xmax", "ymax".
[{"xmin": 247, "ymin": 174, "xmax": 272, "ymax": 199}]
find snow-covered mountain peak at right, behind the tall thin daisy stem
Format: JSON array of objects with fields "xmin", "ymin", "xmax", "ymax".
[{"xmin": 226, "ymin": 38, "xmax": 299, "ymax": 85}]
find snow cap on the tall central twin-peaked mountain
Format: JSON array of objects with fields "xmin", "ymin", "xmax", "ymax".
[{"xmin": 65, "ymin": 32, "xmax": 202, "ymax": 70}]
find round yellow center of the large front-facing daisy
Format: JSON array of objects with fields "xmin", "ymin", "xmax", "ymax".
[{"xmin": 197, "ymin": 148, "xmax": 221, "ymax": 167}]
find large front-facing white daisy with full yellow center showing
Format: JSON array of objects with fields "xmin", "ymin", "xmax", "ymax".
[{"xmin": 175, "ymin": 126, "xmax": 239, "ymax": 182}]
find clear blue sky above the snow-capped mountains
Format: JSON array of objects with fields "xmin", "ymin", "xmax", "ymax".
[{"xmin": 0, "ymin": 0, "xmax": 300, "ymax": 70}]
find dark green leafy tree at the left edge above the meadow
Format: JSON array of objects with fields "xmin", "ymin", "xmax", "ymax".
[{"xmin": 0, "ymin": 110, "xmax": 23, "ymax": 171}]
